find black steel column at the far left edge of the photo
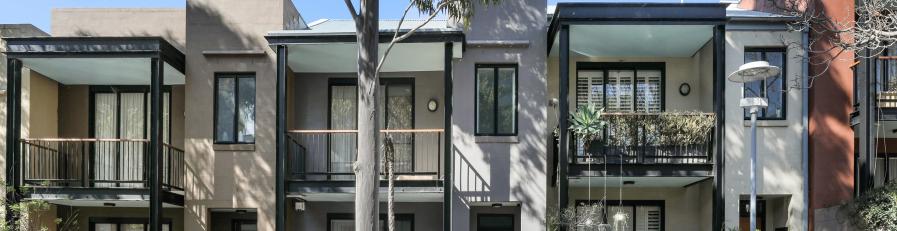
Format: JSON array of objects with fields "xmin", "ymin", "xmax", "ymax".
[{"xmin": 4, "ymin": 59, "xmax": 22, "ymax": 224}]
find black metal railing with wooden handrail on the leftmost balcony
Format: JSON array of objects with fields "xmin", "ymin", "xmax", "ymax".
[{"xmin": 21, "ymin": 138, "xmax": 185, "ymax": 191}]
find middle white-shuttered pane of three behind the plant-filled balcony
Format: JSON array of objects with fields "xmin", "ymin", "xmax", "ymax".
[{"xmin": 606, "ymin": 70, "xmax": 635, "ymax": 112}]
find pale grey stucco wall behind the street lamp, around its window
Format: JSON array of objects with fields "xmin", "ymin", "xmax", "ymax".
[{"xmin": 722, "ymin": 28, "xmax": 806, "ymax": 228}]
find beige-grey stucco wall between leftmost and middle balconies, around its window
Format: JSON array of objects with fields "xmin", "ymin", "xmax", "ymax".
[{"xmin": 184, "ymin": 0, "xmax": 294, "ymax": 231}]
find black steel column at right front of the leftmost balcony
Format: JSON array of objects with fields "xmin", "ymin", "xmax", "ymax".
[{"xmin": 149, "ymin": 58, "xmax": 165, "ymax": 231}]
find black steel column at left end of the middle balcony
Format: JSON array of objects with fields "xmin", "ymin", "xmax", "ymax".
[{"xmin": 274, "ymin": 45, "xmax": 287, "ymax": 231}]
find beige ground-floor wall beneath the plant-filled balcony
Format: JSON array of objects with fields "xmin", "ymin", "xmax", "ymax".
[{"xmin": 569, "ymin": 178, "xmax": 713, "ymax": 231}]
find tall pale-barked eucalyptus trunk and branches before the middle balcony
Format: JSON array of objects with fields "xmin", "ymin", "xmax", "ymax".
[{"xmin": 344, "ymin": 0, "xmax": 500, "ymax": 231}]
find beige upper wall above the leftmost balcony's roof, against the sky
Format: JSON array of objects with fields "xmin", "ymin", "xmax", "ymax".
[{"xmin": 50, "ymin": 8, "xmax": 187, "ymax": 51}]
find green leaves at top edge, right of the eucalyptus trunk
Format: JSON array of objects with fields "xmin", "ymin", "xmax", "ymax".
[{"xmin": 411, "ymin": 0, "xmax": 501, "ymax": 27}]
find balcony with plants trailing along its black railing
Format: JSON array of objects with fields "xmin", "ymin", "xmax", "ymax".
[{"xmin": 569, "ymin": 113, "xmax": 716, "ymax": 176}]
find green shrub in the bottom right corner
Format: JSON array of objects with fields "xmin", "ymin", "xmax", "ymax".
[{"xmin": 851, "ymin": 182, "xmax": 897, "ymax": 230}]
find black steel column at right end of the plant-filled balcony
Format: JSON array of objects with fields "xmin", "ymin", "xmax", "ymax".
[{"xmin": 712, "ymin": 25, "xmax": 726, "ymax": 230}]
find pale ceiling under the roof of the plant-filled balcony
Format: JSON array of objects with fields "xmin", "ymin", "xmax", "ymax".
[{"xmin": 551, "ymin": 25, "xmax": 713, "ymax": 58}]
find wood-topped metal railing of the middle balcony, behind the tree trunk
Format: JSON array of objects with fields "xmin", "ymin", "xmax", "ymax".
[{"xmin": 287, "ymin": 129, "xmax": 444, "ymax": 181}]
